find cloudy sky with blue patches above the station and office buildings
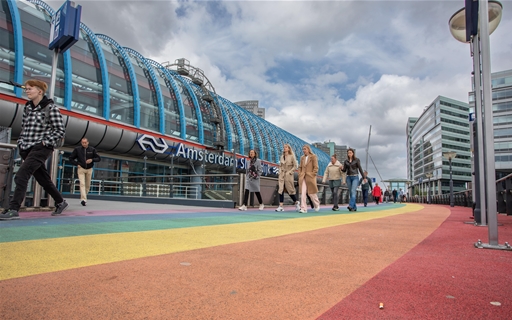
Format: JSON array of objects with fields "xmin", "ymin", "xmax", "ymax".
[{"xmin": 47, "ymin": 0, "xmax": 512, "ymax": 180}]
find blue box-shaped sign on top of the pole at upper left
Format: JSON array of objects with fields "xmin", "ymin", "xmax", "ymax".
[{"xmin": 48, "ymin": 1, "xmax": 82, "ymax": 52}]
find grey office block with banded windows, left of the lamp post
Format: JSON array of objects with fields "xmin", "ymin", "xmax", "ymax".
[{"xmin": 407, "ymin": 96, "xmax": 472, "ymax": 194}]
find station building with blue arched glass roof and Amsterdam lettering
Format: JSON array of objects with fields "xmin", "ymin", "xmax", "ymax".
[{"xmin": 0, "ymin": 0, "xmax": 329, "ymax": 199}]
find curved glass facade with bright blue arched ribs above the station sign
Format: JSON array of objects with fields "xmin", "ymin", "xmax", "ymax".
[{"xmin": 0, "ymin": 0, "xmax": 329, "ymax": 179}]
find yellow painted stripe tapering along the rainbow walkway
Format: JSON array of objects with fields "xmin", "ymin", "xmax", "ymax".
[{"xmin": 0, "ymin": 204, "xmax": 423, "ymax": 280}]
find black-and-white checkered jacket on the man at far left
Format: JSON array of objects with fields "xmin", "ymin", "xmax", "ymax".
[{"xmin": 18, "ymin": 96, "xmax": 66, "ymax": 150}]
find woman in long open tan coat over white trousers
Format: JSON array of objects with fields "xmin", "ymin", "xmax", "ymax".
[{"xmin": 299, "ymin": 144, "xmax": 320, "ymax": 213}]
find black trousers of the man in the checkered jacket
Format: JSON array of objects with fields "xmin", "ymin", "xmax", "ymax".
[{"xmin": 9, "ymin": 143, "xmax": 64, "ymax": 211}]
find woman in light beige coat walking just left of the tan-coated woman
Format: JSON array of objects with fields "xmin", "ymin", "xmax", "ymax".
[{"xmin": 276, "ymin": 143, "xmax": 300, "ymax": 212}]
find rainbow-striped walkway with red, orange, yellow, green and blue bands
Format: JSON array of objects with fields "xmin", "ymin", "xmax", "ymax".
[{"xmin": 0, "ymin": 200, "xmax": 512, "ymax": 320}]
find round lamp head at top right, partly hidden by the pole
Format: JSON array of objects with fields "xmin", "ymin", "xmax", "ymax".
[{"xmin": 448, "ymin": 0, "xmax": 503, "ymax": 43}]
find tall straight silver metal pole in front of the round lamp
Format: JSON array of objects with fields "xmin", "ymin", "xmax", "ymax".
[{"xmin": 478, "ymin": 0, "xmax": 498, "ymax": 246}]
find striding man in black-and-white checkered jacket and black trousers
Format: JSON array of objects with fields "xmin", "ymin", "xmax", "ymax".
[{"xmin": 0, "ymin": 80, "xmax": 68, "ymax": 220}]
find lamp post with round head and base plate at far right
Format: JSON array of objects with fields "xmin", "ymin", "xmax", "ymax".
[{"xmin": 449, "ymin": 0, "xmax": 509, "ymax": 250}]
